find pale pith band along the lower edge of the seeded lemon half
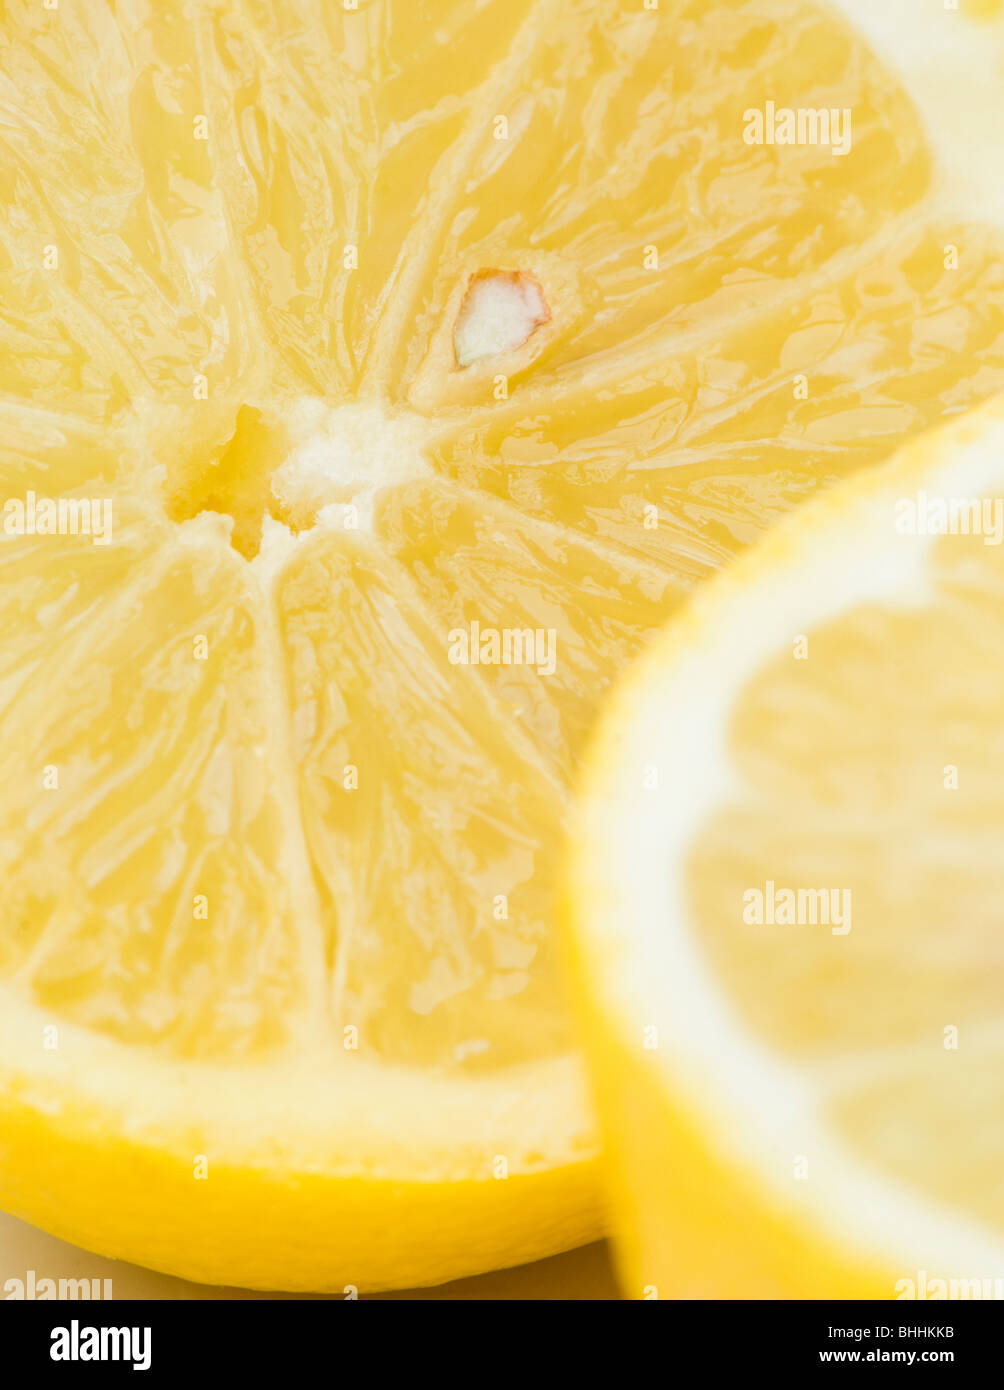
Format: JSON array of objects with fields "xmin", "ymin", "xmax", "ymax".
[{"xmin": 0, "ymin": 995, "xmax": 595, "ymax": 1182}]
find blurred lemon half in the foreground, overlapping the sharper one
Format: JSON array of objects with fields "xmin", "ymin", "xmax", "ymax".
[{"xmin": 569, "ymin": 403, "xmax": 1004, "ymax": 1298}]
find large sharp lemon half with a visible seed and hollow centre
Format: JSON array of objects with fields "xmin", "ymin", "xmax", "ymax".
[{"xmin": 0, "ymin": 0, "xmax": 1004, "ymax": 1290}]
